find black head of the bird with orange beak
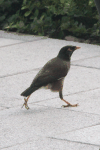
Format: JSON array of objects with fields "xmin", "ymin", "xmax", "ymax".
[{"xmin": 57, "ymin": 45, "xmax": 80, "ymax": 60}]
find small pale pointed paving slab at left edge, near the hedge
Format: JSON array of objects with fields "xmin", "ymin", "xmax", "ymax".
[{"xmin": 0, "ymin": 38, "xmax": 23, "ymax": 47}]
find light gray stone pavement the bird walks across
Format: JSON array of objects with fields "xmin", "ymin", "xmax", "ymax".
[{"xmin": 0, "ymin": 31, "xmax": 100, "ymax": 150}]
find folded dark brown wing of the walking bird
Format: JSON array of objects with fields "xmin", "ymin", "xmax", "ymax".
[{"xmin": 31, "ymin": 58, "xmax": 68, "ymax": 87}]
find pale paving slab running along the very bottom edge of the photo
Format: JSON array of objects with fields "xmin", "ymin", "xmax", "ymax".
[{"xmin": 3, "ymin": 136, "xmax": 99, "ymax": 150}]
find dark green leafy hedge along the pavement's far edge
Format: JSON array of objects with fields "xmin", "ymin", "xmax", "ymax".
[{"xmin": 0, "ymin": 0, "xmax": 100, "ymax": 38}]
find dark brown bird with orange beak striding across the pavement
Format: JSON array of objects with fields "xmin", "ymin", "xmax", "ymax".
[{"xmin": 21, "ymin": 45, "xmax": 81, "ymax": 110}]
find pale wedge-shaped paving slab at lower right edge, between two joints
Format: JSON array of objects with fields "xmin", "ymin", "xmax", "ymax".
[{"xmin": 55, "ymin": 125, "xmax": 100, "ymax": 147}]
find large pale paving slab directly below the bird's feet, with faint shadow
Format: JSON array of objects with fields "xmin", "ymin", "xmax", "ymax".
[{"xmin": 0, "ymin": 104, "xmax": 100, "ymax": 149}]
